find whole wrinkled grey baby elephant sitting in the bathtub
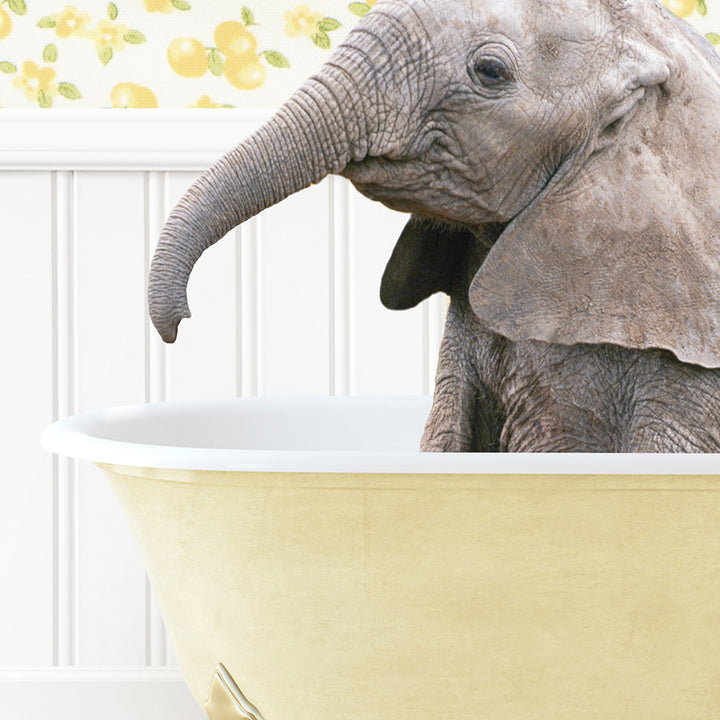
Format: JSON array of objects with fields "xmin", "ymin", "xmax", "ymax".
[{"xmin": 149, "ymin": 0, "xmax": 720, "ymax": 452}]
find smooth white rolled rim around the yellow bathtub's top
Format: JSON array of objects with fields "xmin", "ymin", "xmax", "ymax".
[{"xmin": 41, "ymin": 396, "xmax": 720, "ymax": 475}]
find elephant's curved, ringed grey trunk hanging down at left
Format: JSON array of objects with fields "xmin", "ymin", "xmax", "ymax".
[{"xmin": 148, "ymin": 78, "xmax": 367, "ymax": 342}]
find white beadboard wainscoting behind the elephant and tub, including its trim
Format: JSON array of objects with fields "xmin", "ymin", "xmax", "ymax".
[{"xmin": 0, "ymin": 110, "xmax": 445, "ymax": 720}]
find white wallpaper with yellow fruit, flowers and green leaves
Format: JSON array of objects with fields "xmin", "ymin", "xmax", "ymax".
[{"xmin": 0, "ymin": 0, "xmax": 720, "ymax": 108}]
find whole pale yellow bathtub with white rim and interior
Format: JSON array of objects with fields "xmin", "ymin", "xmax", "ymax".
[{"xmin": 43, "ymin": 398, "xmax": 720, "ymax": 720}]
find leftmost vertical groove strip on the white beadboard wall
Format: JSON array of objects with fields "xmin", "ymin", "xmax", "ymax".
[{"xmin": 53, "ymin": 171, "xmax": 78, "ymax": 666}]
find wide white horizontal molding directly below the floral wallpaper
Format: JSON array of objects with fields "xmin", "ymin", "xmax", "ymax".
[{"xmin": 0, "ymin": 109, "xmax": 273, "ymax": 171}]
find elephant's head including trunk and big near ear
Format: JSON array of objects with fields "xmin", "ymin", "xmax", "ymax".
[{"xmin": 149, "ymin": 0, "xmax": 720, "ymax": 367}]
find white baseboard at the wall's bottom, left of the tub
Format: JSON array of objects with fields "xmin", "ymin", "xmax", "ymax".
[{"xmin": 0, "ymin": 668, "xmax": 207, "ymax": 720}]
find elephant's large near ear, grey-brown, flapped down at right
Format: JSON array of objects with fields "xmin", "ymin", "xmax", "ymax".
[{"xmin": 469, "ymin": 15, "xmax": 720, "ymax": 367}]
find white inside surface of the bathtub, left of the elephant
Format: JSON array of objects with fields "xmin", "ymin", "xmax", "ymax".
[{"xmin": 67, "ymin": 397, "xmax": 430, "ymax": 452}]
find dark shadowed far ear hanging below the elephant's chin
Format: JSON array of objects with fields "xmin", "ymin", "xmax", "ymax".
[{"xmin": 380, "ymin": 215, "xmax": 475, "ymax": 310}]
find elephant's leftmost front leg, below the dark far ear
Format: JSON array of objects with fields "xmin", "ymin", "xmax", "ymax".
[{"xmin": 420, "ymin": 302, "xmax": 505, "ymax": 452}]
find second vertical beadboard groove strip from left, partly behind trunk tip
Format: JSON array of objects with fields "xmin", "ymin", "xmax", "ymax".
[{"xmin": 144, "ymin": 172, "xmax": 169, "ymax": 667}]
